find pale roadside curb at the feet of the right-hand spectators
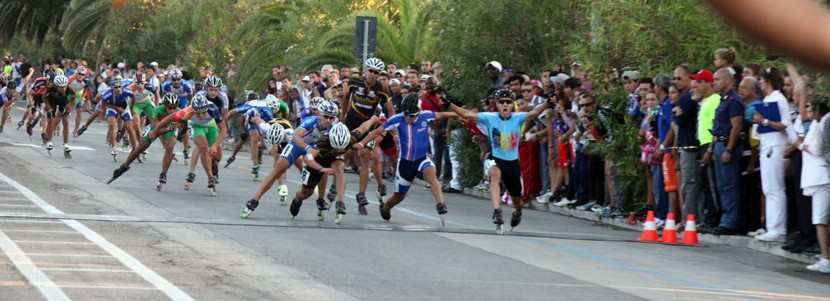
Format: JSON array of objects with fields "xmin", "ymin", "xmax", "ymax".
[{"xmin": 463, "ymin": 188, "xmax": 816, "ymax": 264}]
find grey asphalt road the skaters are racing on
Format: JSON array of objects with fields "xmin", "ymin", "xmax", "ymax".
[{"xmin": 0, "ymin": 103, "xmax": 830, "ymax": 301}]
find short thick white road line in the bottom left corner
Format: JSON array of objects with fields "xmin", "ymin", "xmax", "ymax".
[{"xmin": 0, "ymin": 231, "xmax": 70, "ymax": 301}]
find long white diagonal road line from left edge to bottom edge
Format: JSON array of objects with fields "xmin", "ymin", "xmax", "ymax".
[{"xmin": 0, "ymin": 173, "xmax": 193, "ymax": 301}]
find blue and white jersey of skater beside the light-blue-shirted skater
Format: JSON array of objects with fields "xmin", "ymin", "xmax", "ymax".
[{"xmin": 383, "ymin": 111, "xmax": 435, "ymax": 161}]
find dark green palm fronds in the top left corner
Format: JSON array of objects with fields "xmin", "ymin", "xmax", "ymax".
[{"xmin": 0, "ymin": 0, "xmax": 69, "ymax": 44}]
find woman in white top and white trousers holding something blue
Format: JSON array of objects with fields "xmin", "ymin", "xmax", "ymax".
[{"xmin": 752, "ymin": 68, "xmax": 792, "ymax": 242}]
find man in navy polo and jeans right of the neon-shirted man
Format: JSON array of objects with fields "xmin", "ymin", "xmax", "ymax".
[{"xmin": 709, "ymin": 67, "xmax": 744, "ymax": 235}]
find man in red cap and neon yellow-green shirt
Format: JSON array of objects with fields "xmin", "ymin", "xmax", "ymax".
[{"xmin": 692, "ymin": 69, "xmax": 721, "ymax": 231}]
